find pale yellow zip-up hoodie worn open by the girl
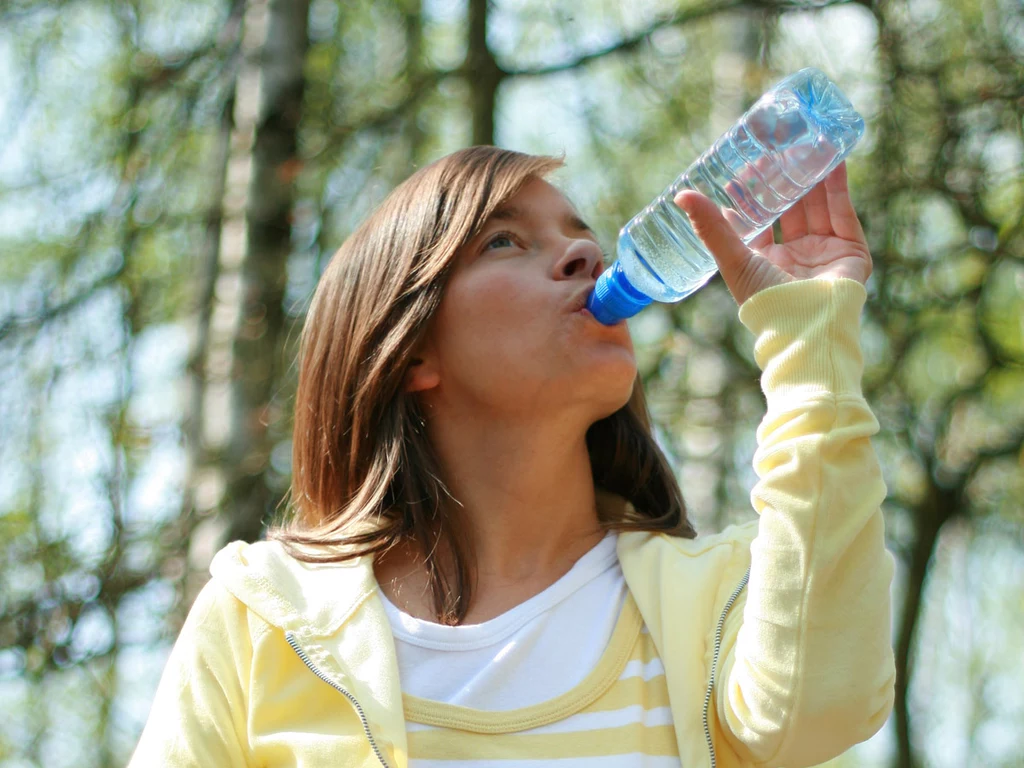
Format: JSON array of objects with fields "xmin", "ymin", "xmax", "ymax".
[{"xmin": 130, "ymin": 279, "xmax": 895, "ymax": 768}]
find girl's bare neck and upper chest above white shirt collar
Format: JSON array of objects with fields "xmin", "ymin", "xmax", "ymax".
[{"xmin": 375, "ymin": 403, "xmax": 604, "ymax": 624}]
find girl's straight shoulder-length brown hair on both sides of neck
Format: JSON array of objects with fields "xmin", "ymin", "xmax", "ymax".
[{"xmin": 267, "ymin": 146, "xmax": 696, "ymax": 624}]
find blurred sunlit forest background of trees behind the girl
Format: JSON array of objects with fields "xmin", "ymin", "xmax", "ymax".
[{"xmin": 0, "ymin": 0, "xmax": 1024, "ymax": 768}]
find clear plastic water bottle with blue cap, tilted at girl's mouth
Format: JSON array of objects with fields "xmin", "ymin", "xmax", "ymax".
[{"xmin": 587, "ymin": 68, "xmax": 864, "ymax": 325}]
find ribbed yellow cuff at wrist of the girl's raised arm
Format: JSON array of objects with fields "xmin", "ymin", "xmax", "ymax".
[{"xmin": 739, "ymin": 278, "xmax": 867, "ymax": 408}]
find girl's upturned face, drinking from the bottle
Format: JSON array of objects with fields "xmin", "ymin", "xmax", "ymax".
[{"xmin": 413, "ymin": 179, "xmax": 637, "ymax": 425}]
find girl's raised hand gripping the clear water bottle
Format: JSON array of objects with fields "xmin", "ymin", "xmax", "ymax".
[{"xmin": 675, "ymin": 162, "xmax": 871, "ymax": 304}]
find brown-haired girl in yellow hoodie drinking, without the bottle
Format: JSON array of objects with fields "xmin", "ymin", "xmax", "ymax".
[{"xmin": 131, "ymin": 146, "xmax": 895, "ymax": 768}]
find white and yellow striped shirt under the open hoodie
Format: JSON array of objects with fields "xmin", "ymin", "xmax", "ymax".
[{"xmin": 385, "ymin": 534, "xmax": 680, "ymax": 768}]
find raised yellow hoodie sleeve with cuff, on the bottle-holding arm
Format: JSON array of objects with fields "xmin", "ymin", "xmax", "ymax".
[{"xmin": 715, "ymin": 279, "xmax": 895, "ymax": 768}]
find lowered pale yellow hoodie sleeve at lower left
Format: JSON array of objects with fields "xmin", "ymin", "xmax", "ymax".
[{"xmin": 128, "ymin": 580, "xmax": 252, "ymax": 768}]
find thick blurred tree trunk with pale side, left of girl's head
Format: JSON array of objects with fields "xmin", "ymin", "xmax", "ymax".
[{"xmin": 185, "ymin": 0, "xmax": 308, "ymax": 573}]
